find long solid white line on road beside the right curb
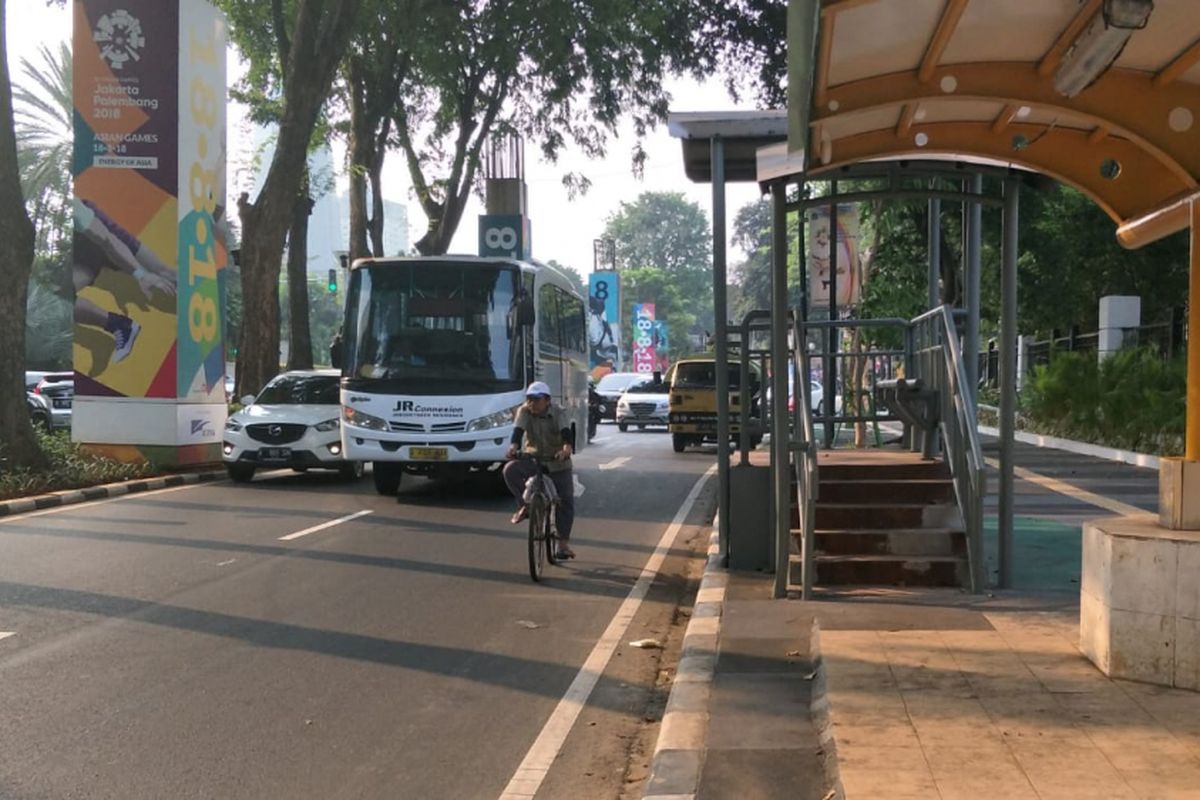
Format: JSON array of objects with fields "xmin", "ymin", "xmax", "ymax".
[{"xmin": 500, "ymin": 464, "xmax": 716, "ymax": 800}]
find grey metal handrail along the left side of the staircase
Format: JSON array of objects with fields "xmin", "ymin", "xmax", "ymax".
[{"xmin": 775, "ymin": 314, "xmax": 821, "ymax": 600}]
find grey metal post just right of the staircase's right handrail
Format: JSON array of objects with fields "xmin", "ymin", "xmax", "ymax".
[{"xmin": 998, "ymin": 178, "xmax": 1021, "ymax": 589}]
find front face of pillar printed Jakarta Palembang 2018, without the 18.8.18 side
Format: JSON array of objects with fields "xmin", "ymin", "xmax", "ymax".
[{"xmin": 71, "ymin": 0, "xmax": 179, "ymax": 398}]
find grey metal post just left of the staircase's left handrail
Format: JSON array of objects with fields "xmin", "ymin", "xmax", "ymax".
[{"xmin": 770, "ymin": 181, "xmax": 804, "ymax": 597}]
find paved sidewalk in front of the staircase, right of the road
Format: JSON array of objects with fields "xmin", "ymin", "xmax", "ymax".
[{"xmin": 644, "ymin": 438, "xmax": 1200, "ymax": 800}]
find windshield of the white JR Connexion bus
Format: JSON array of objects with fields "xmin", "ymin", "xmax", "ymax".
[{"xmin": 343, "ymin": 259, "xmax": 524, "ymax": 395}]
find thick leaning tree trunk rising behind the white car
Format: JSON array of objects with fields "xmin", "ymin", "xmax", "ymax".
[{"xmin": 238, "ymin": 0, "xmax": 361, "ymax": 393}]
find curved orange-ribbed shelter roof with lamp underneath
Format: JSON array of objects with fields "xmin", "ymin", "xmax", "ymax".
[{"xmin": 788, "ymin": 0, "xmax": 1200, "ymax": 247}]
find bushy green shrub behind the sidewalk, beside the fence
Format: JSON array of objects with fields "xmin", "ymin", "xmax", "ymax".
[{"xmin": 1021, "ymin": 348, "xmax": 1187, "ymax": 455}]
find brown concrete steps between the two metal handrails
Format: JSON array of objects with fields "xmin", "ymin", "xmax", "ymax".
[{"xmin": 791, "ymin": 450, "xmax": 970, "ymax": 587}]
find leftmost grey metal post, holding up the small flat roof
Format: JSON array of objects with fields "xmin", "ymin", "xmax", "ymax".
[{"xmin": 710, "ymin": 137, "xmax": 730, "ymax": 563}]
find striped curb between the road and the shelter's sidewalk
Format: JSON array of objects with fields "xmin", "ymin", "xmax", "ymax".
[{"xmin": 642, "ymin": 521, "xmax": 728, "ymax": 800}]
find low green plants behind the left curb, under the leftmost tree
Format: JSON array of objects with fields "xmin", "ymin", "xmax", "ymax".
[{"xmin": 0, "ymin": 431, "xmax": 157, "ymax": 500}]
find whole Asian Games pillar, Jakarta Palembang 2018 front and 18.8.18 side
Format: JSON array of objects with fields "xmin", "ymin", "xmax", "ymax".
[{"xmin": 72, "ymin": 0, "xmax": 227, "ymax": 458}]
